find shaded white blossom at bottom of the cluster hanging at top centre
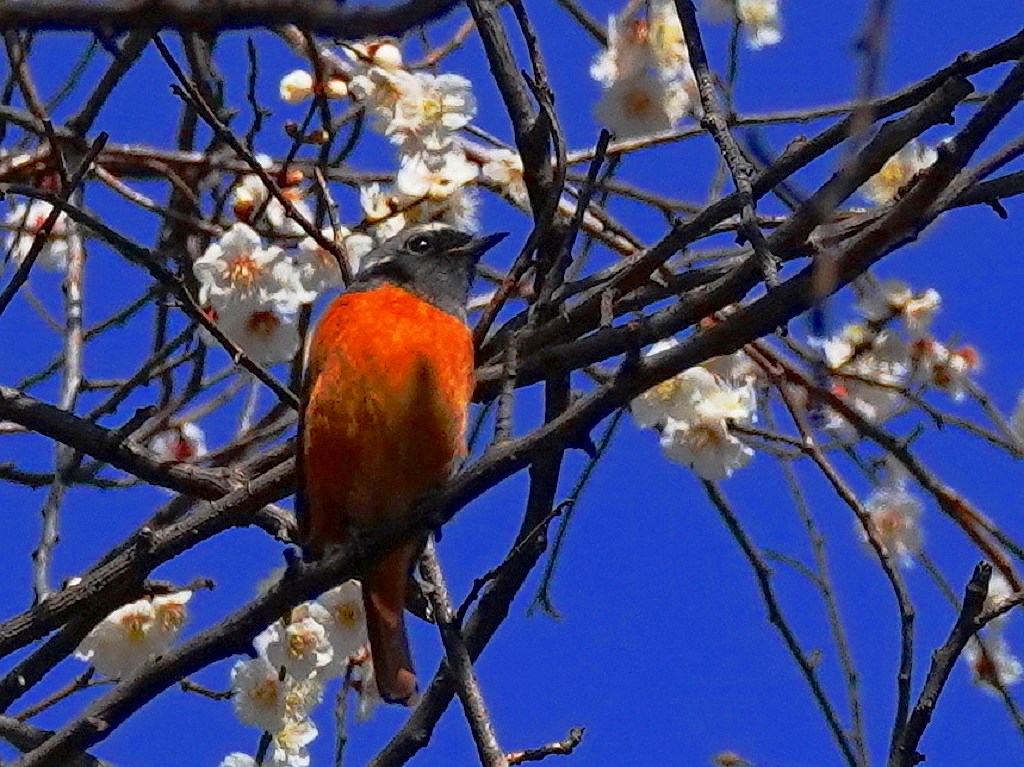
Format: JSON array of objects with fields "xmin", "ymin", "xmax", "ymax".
[{"xmin": 594, "ymin": 71, "xmax": 691, "ymax": 138}]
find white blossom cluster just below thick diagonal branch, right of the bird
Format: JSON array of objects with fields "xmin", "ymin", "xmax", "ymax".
[{"xmin": 631, "ymin": 340, "xmax": 757, "ymax": 480}]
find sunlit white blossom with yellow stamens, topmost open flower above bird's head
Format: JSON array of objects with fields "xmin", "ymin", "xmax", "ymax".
[{"xmin": 386, "ymin": 72, "xmax": 476, "ymax": 152}]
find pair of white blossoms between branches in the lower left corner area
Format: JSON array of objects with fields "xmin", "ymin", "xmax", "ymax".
[{"xmin": 71, "ymin": 587, "xmax": 193, "ymax": 679}]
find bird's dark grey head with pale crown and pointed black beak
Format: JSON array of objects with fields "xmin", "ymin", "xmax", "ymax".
[{"xmin": 352, "ymin": 223, "xmax": 506, "ymax": 319}]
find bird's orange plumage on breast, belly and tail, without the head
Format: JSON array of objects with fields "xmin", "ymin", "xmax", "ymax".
[{"xmin": 300, "ymin": 284, "xmax": 473, "ymax": 700}]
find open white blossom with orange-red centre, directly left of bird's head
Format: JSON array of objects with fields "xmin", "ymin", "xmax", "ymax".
[{"xmin": 193, "ymin": 223, "xmax": 287, "ymax": 310}]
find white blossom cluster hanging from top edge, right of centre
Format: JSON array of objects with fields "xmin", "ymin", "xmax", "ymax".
[{"xmin": 590, "ymin": 0, "xmax": 699, "ymax": 138}]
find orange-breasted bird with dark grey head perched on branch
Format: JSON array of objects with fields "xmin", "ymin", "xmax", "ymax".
[{"xmin": 296, "ymin": 223, "xmax": 505, "ymax": 705}]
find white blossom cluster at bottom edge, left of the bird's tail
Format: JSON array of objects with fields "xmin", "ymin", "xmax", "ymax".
[{"xmin": 223, "ymin": 581, "xmax": 380, "ymax": 767}]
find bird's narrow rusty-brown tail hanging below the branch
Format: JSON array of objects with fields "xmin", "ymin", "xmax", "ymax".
[{"xmin": 362, "ymin": 544, "xmax": 418, "ymax": 706}]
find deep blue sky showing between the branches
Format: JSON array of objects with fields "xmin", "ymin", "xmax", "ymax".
[{"xmin": 0, "ymin": 0, "xmax": 1024, "ymax": 767}]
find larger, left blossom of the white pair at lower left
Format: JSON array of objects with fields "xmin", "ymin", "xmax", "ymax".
[{"xmin": 75, "ymin": 599, "xmax": 183, "ymax": 679}]
